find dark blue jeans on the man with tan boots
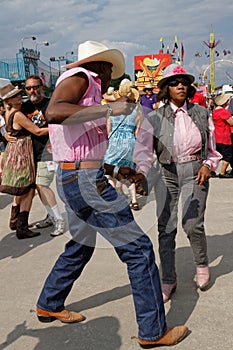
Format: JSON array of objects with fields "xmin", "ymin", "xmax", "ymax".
[{"xmin": 37, "ymin": 162, "xmax": 166, "ymax": 340}]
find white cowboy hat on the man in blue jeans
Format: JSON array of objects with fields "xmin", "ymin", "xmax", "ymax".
[{"xmin": 64, "ymin": 41, "xmax": 125, "ymax": 79}]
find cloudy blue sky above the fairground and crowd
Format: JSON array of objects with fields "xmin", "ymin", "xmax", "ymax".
[{"xmin": 0, "ymin": 0, "xmax": 233, "ymax": 85}]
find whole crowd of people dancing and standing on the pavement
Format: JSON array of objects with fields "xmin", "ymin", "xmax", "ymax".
[{"xmin": 0, "ymin": 41, "xmax": 233, "ymax": 348}]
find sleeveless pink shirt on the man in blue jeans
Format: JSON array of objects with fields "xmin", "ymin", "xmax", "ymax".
[{"xmin": 49, "ymin": 68, "xmax": 108, "ymax": 162}]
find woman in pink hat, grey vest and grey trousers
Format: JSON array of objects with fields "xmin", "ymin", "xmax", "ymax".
[{"xmin": 132, "ymin": 64, "xmax": 221, "ymax": 302}]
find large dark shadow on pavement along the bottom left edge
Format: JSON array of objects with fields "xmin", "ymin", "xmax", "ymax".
[{"xmin": 0, "ymin": 317, "xmax": 121, "ymax": 350}]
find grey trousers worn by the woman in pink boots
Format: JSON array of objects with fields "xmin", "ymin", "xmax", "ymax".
[{"xmin": 155, "ymin": 161, "xmax": 209, "ymax": 284}]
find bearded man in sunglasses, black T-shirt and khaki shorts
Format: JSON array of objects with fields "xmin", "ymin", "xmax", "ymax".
[{"xmin": 22, "ymin": 75, "xmax": 64, "ymax": 236}]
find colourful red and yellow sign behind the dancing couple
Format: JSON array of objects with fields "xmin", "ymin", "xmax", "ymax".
[{"xmin": 134, "ymin": 53, "xmax": 171, "ymax": 91}]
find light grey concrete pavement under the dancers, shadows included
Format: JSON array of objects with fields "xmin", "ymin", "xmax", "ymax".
[{"xmin": 0, "ymin": 178, "xmax": 233, "ymax": 350}]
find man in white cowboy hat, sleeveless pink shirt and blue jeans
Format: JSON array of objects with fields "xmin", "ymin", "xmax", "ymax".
[{"xmin": 37, "ymin": 41, "xmax": 188, "ymax": 347}]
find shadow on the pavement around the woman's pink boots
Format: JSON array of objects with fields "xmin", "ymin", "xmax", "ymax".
[{"xmin": 164, "ymin": 232, "xmax": 233, "ymax": 327}]
